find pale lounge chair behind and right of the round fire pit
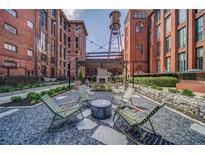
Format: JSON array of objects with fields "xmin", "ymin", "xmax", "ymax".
[{"xmin": 112, "ymin": 87, "xmax": 135, "ymax": 106}]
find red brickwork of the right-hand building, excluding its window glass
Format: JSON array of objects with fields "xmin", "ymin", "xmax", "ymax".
[{"xmin": 124, "ymin": 9, "xmax": 205, "ymax": 75}]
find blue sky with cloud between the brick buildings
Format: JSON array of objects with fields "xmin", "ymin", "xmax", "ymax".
[{"xmin": 64, "ymin": 9, "xmax": 128, "ymax": 52}]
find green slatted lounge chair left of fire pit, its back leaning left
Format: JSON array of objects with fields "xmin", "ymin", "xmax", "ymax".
[{"xmin": 41, "ymin": 94, "xmax": 84, "ymax": 131}]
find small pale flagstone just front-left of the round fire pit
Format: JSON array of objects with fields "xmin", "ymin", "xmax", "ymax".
[{"xmin": 77, "ymin": 118, "xmax": 97, "ymax": 130}]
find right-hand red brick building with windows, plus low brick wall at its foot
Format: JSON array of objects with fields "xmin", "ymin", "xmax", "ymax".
[{"xmin": 124, "ymin": 9, "xmax": 205, "ymax": 92}]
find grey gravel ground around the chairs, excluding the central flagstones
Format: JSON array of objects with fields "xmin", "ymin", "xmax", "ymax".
[{"xmin": 0, "ymin": 88, "xmax": 205, "ymax": 145}]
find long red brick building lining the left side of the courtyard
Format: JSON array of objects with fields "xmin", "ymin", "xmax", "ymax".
[{"xmin": 0, "ymin": 9, "xmax": 87, "ymax": 78}]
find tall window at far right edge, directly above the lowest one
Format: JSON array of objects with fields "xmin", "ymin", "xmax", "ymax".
[{"xmin": 196, "ymin": 16, "xmax": 204, "ymax": 41}]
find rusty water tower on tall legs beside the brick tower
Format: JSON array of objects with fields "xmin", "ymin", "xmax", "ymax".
[{"xmin": 108, "ymin": 10, "xmax": 122, "ymax": 59}]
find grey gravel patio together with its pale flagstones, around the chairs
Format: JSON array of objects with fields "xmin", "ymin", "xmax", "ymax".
[{"xmin": 0, "ymin": 88, "xmax": 205, "ymax": 145}]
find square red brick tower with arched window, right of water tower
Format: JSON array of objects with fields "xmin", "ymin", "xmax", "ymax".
[{"xmin": 124, "ymin": 9, "xmax": 150, "ymax": 75}]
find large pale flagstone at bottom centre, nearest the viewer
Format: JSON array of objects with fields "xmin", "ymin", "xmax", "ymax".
[{"xmin": 92, "ymin": 126, "xmax": 128, "ymax": 145}]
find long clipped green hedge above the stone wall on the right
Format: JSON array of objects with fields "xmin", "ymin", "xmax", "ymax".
[{"xmin": 129, "ymin": 76, "xmax": 177, "ymax": 87}]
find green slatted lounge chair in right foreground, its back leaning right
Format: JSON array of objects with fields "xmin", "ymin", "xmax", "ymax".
[{"xmin": 113, "ymin": 103, "xmax": 165, "ymax": 144}]
